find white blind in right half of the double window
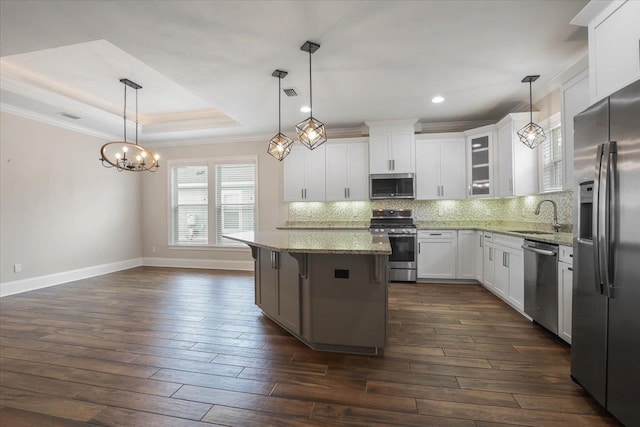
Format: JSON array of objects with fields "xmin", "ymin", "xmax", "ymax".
[{"xmin": 215, "ymin": 163, "xmax": 255, "ymax": 246}]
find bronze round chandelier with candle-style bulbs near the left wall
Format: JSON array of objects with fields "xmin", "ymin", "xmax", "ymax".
[{"xmin": 100, "ymin": 79, "xmax": 160, "ymax": 172}]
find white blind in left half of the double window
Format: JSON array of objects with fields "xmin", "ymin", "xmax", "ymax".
[{"xmin": 171, "ymin": 165, "xmax": 209, "ymax": 245}]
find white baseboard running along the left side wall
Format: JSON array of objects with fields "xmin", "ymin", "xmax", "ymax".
[{"xmin": 0, "ymin": 258, "xmax": 143, "ymax": 297}]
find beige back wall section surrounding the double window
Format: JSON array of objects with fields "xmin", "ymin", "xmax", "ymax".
[{"xmin": 142, "ymin": 137, "xmax": 288, "ymax": 268}]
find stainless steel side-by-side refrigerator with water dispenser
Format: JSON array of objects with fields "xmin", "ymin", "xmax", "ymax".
[{"xmin": 571, "ymin": 80, "xmax": 640, "ymax": 426}]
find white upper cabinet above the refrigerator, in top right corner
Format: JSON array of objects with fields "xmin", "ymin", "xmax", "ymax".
[{"xmin": 571, "ymin": 0, "xmax": 640, "ymax": 104}]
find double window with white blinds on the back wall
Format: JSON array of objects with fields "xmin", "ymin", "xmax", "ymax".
[{"xmin": 169, "ymin": 159, "xmax": 256, "ymax": 246}]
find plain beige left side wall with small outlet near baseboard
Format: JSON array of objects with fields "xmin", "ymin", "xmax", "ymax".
[{"xmin": 0, "ymin": 113, "xmax": 142, "ymax": 283}]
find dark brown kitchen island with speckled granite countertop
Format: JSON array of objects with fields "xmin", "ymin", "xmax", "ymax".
[{"xmin": 224, "ymin": 230, "xmax": 391, "ymax": 355}]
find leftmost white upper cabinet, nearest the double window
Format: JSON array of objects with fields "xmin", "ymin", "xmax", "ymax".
[{"xmin": 284, "ymin": 144, "xmax": 326, "ymax": 202}]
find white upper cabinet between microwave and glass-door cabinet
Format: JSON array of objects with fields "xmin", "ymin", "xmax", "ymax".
[{"xmin": 416, "ymin": 133, "xmax": 467, "ymax": 199}]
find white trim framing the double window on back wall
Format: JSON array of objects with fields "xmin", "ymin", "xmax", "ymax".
[{"xmin": 166, "ymin": 154, "xmax": 260, "ymax": 252}]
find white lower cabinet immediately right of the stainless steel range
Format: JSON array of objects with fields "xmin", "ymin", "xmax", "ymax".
[{"xmin": 418, "ymin": 230, "xmax": 458, "ymax": 279}]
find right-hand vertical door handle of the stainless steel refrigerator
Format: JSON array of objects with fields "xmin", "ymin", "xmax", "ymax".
[{"xmin": 603, "ymin": 141, "xmax": 618, "ymax": 298}]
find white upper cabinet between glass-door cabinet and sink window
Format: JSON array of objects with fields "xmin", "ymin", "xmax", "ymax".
[{"xmin": 496, "ymin": 113, "xmax": 538, "ymax": 197}]
